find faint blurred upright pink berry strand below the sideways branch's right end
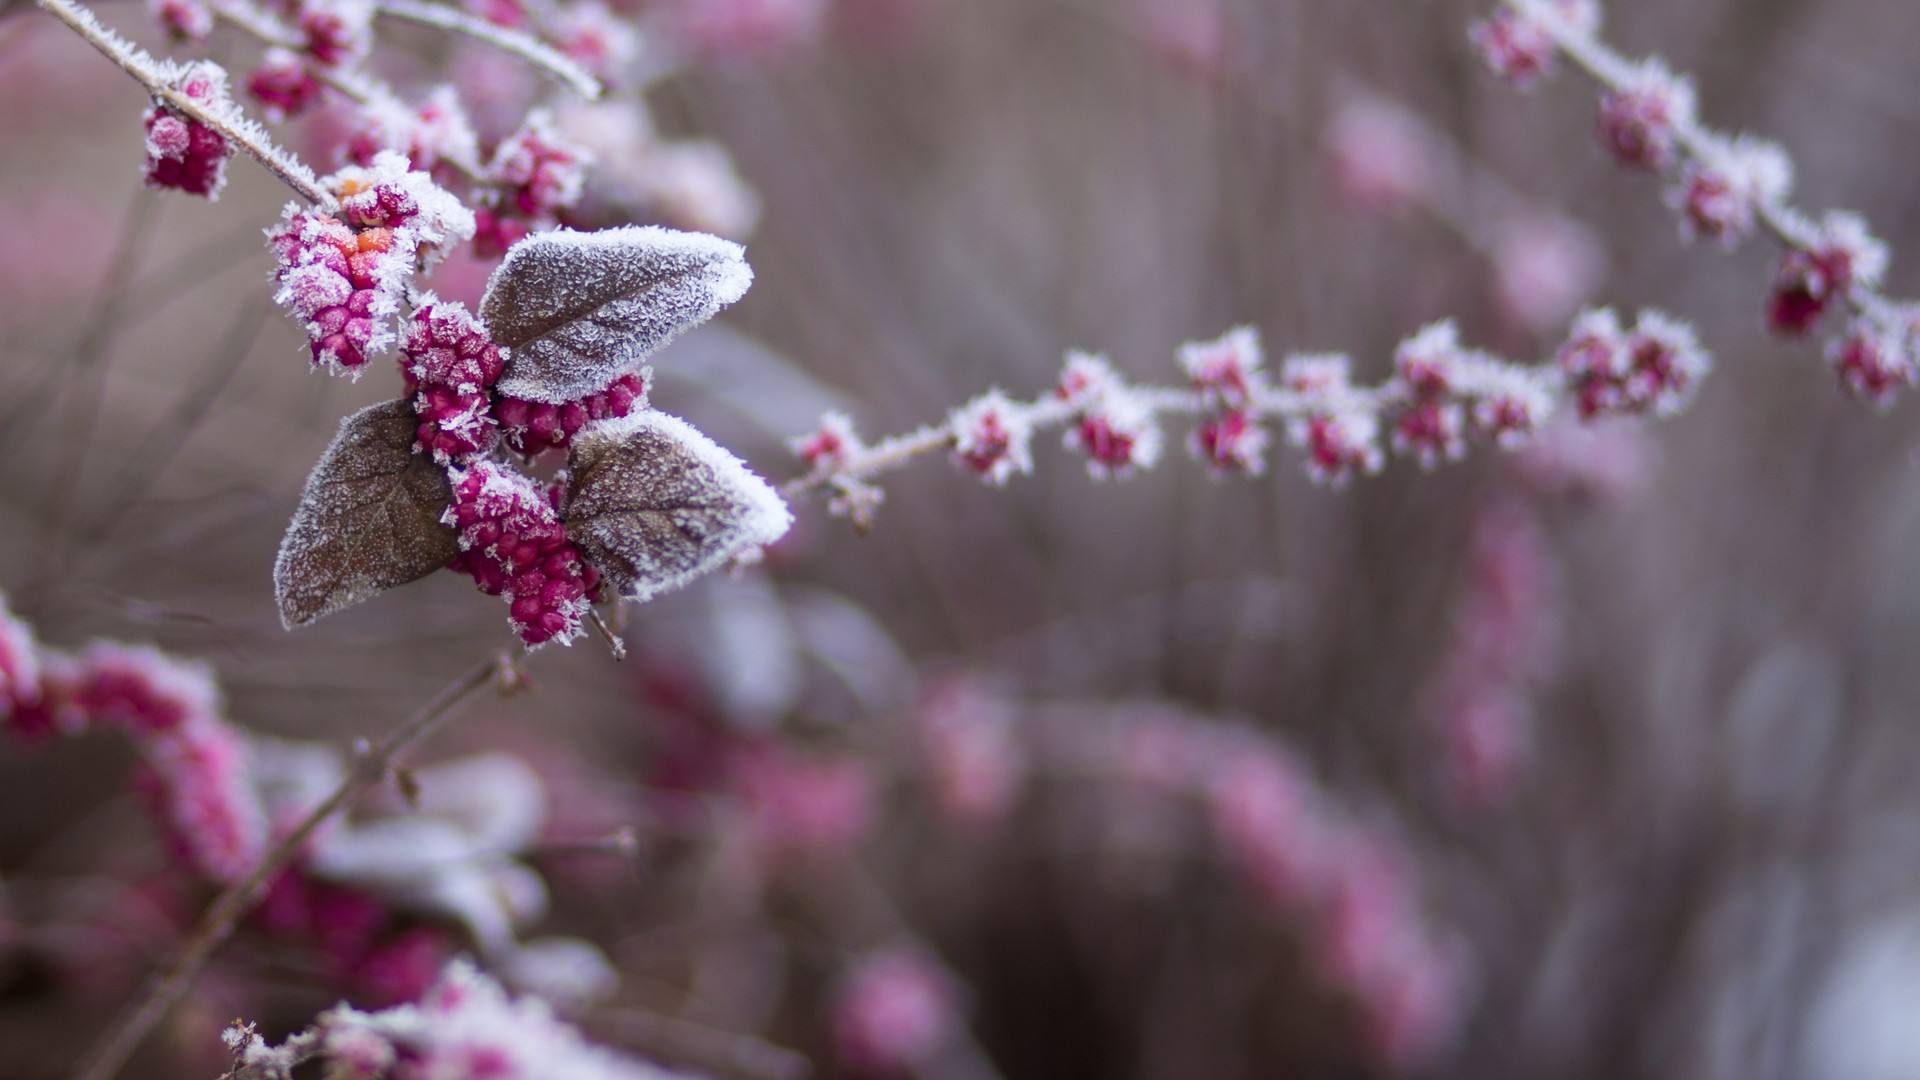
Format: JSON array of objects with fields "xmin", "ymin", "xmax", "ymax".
[{"xmin": 1430, "ymin": 500, "xmax": 1557, "ymax": 805}]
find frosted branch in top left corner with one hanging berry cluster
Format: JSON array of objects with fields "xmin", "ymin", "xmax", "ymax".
[{"xmin": 38, "ymin": 0, "xmax": 334, "ymax": 209}]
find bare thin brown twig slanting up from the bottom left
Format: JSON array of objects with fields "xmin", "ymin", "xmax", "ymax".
[{"xmin": 73, "ymin": 659, "xmax": 511, "ymax": 1080}]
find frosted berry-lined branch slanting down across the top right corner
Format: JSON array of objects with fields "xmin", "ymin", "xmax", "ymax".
[{"xmin": 1473, "ymin": 0, "xmax": 1920, "ymax": 404}]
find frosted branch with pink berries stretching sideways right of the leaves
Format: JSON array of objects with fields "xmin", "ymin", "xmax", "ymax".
[{"xmin": 781, "ymin": 311, "xmax": 1711, "ymax": 527}]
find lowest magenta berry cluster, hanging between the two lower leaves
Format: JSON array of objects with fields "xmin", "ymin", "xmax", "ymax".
[{"xmin": 445, "ymin": 459, "xmax": 599, "ymax": 646}]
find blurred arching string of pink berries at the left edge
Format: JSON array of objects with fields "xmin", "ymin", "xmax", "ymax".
[{"xmin": 0, "ymin": 601, "xmax": 267, "ymax": 882}]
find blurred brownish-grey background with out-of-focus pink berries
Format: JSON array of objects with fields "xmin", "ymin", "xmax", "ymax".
[{"xmin": 0, "ymin": 0, "xmax": 1920, "ymax": 1080}]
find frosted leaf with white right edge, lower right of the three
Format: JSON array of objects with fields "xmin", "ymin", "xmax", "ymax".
[{"xmin": 564, "ymin": 409, "xmax": 793, "ymax": 600}]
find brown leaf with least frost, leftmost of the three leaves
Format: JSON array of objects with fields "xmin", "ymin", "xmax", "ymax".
[{"xmin": 273, "ymin": 402, "xmax": 459, "ymax": 628}]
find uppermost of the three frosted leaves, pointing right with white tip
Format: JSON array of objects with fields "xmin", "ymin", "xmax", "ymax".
[{"xmin": 480, "ymin": 225, "xmax": 753, "ymax": 404}]
